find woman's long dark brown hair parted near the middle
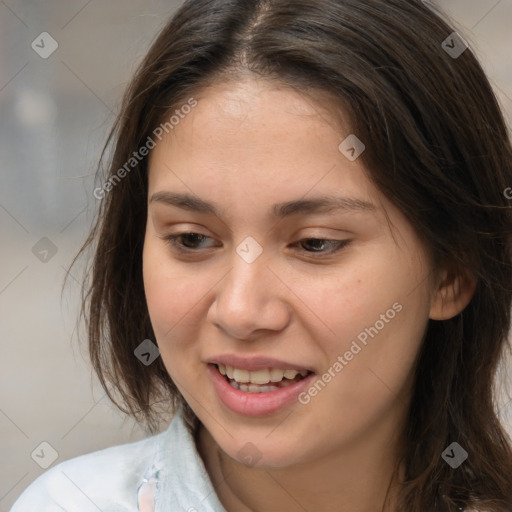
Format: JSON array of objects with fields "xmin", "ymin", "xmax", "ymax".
[{"xmin": 69, "ymin": 0, "xmax": 512, "ymax": 512}]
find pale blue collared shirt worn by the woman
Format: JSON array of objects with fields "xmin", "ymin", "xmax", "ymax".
[{"xmin": 11, "ymin": 411, "xmax": 226, "ymax": 512}]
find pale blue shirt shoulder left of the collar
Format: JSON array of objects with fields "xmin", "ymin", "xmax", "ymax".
[{"xmin": 11, "ymin": 432, "xmax": 166, "ymax": 512}]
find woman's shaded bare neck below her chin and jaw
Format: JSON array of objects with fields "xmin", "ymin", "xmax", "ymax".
[{"xmin": 198, "ymin": 420, "xmax": 406, "ymax": 512}]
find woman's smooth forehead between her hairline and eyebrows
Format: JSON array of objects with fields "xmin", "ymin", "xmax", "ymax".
[{"xmin": 150, "ymin": 80, "xmax": 371, "ymax": 201}]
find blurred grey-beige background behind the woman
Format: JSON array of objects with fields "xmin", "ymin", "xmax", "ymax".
[{"xmin": 0, "ymin": 0, "xmax": 512, "ymax": 512}]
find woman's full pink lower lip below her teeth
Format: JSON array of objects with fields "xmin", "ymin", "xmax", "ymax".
[{"xmin": 208, "ymin": 364, "xmax": 314, "ymax": 416}]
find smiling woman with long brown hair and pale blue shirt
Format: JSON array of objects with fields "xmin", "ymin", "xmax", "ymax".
[{"xmin": 12, "ymin": 0, "xmax": 512, "ymax": 512}]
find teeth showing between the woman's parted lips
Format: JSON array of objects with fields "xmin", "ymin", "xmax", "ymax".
[{"xmin": 215, "ymin": 363, "xmax": 313, "ymax": 393}]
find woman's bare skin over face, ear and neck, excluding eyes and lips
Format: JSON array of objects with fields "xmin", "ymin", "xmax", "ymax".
[{"xmin": 143, "ymin": 78, "xmax": 474, "ymax": 512}]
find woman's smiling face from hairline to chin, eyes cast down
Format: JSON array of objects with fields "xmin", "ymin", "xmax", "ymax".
[{"xmin": 143, "ymin": 80, "xmax": 440, "ymax": 467}]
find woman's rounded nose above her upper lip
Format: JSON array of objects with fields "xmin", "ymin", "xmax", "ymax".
[{"xmin": 208, "ymin": 247, "xmax": 291, "ymax": 340}]
